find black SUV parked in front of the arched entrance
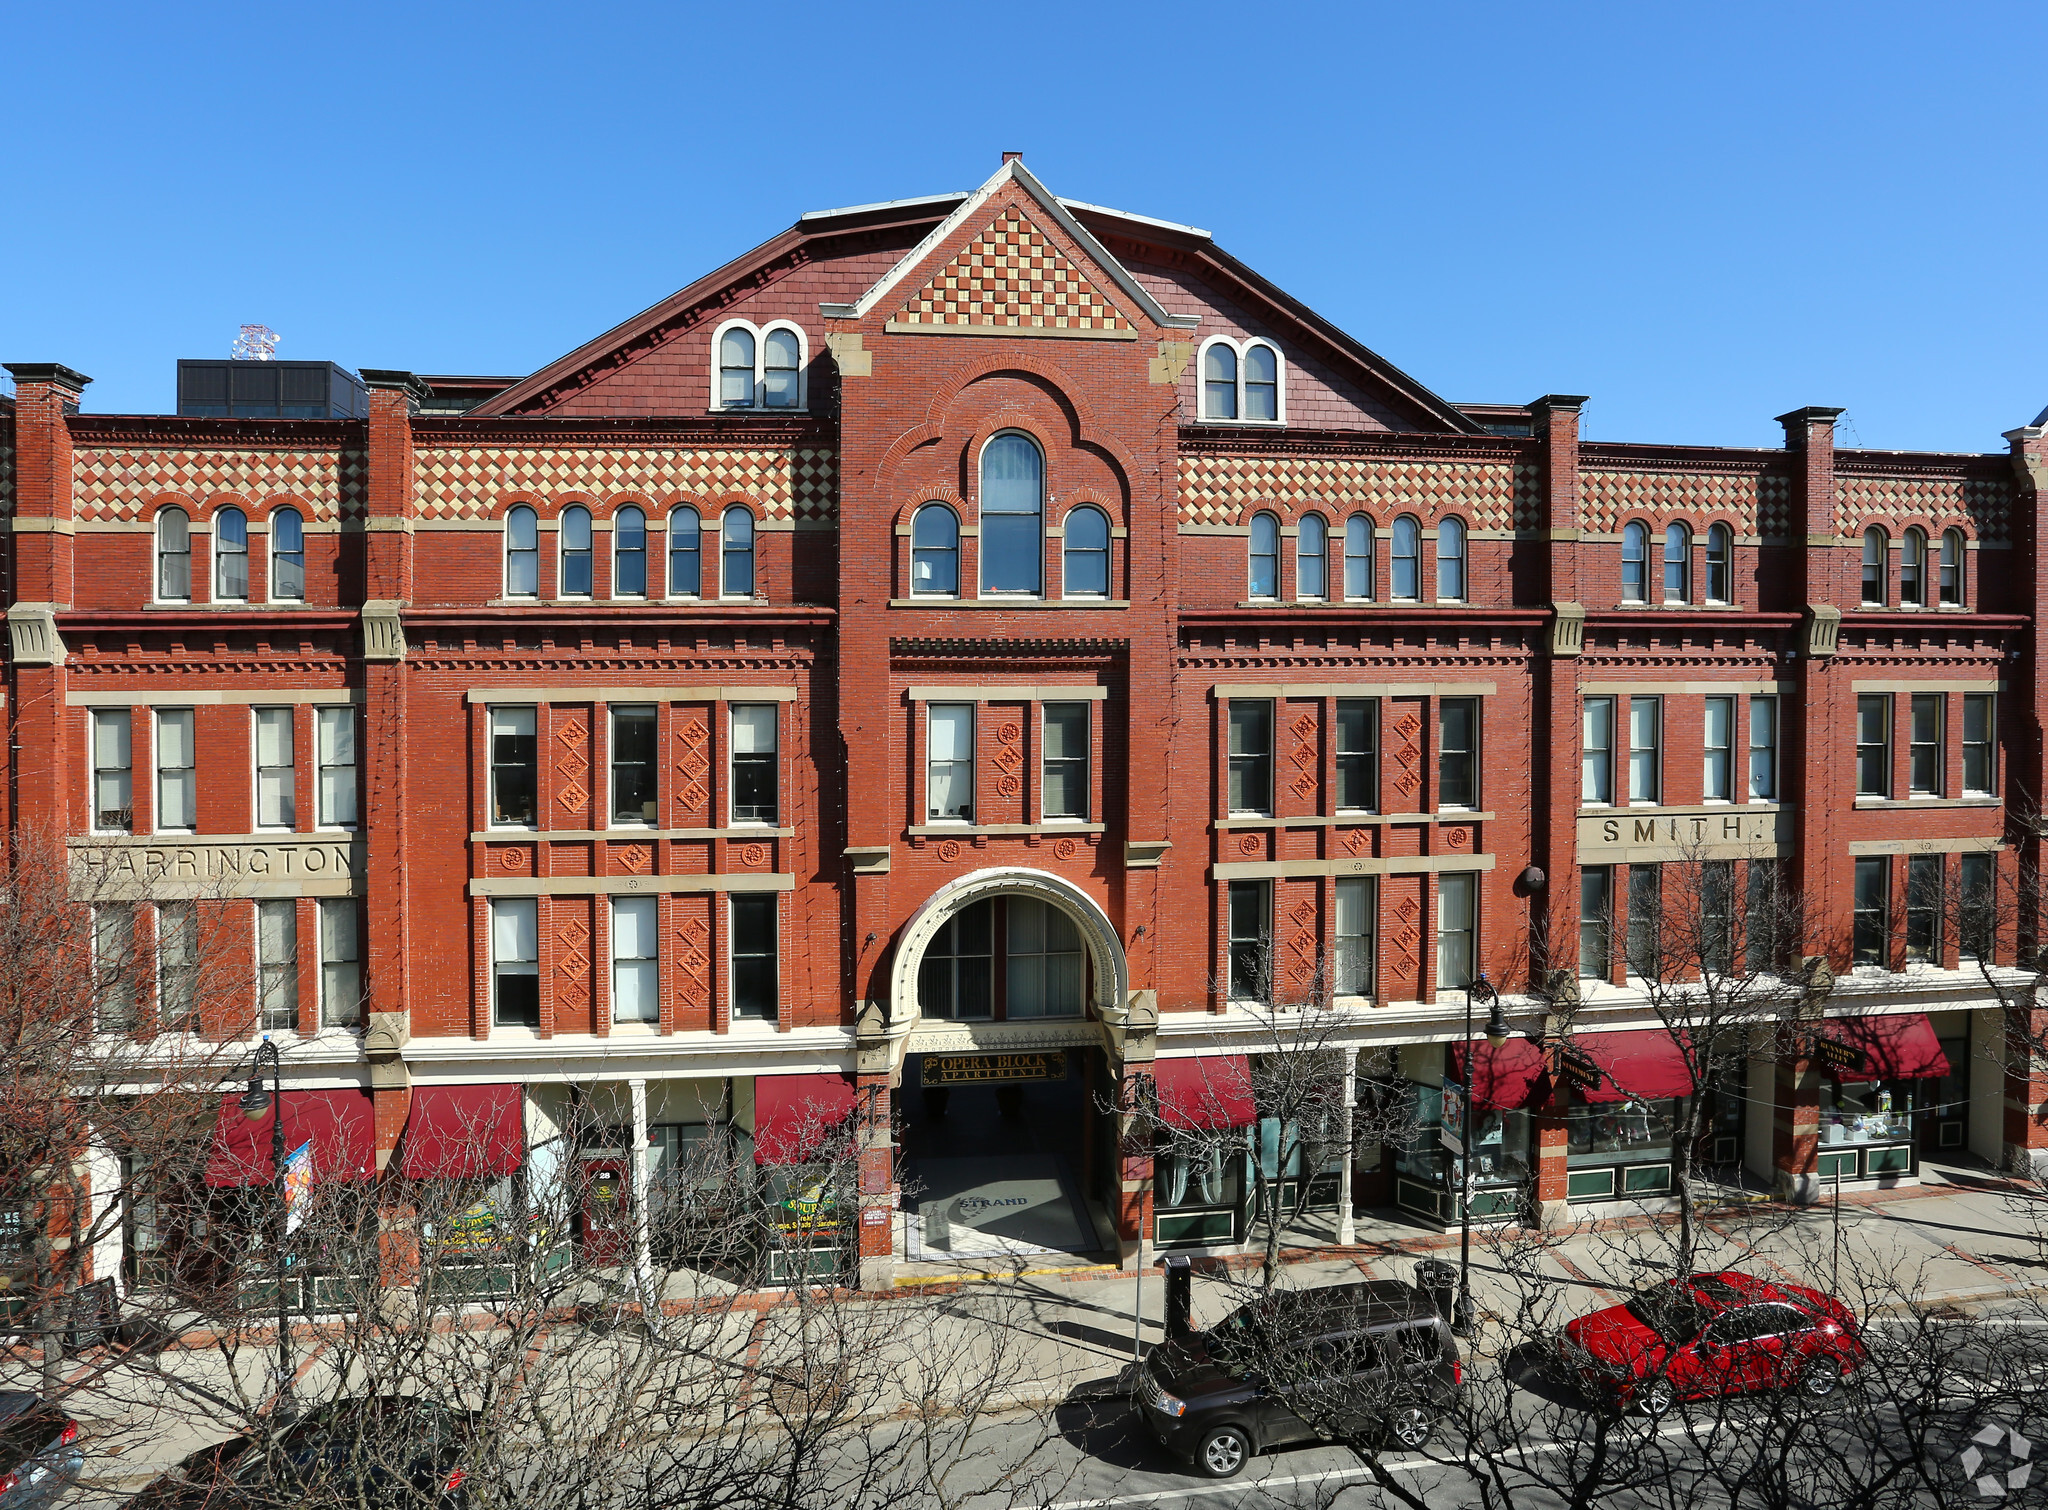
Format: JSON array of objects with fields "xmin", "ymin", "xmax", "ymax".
[{"xmin": 1137, "ymin": 1281, "xmax": 1464, "ymax": 1479}]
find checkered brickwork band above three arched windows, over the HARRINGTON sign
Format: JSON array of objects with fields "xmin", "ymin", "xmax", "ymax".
[{"xmin": 72, "ymin": 447, "xmax": 369, "ymax": 522}]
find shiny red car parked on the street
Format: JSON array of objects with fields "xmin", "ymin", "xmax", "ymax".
[{"xmin": 1559, "ymin": 1272, "xmax": 1866, "ymax": 1416}]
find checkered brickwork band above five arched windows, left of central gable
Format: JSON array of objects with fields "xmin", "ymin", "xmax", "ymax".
[{"xmin": 414, "ymin": 447, "xmax": 838, "ymax": 525}]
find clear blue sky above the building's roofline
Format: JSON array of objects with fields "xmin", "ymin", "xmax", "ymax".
[{"xmin": 0, "ymin": 0, "xmax": 2048, "ymax": 451}]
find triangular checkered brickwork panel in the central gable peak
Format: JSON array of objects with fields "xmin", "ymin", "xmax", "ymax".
[{"xmin": 891, "ymin": 205, "xmax": 1133, "ymax": 334}]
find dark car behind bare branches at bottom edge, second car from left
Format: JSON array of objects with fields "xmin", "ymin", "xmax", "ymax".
[{"xmin": 127, "ymin": 1395, "xmax": 481, "ymax": 1510}]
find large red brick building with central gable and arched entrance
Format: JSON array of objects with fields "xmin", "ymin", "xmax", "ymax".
[{"xmin": 0, "ymin": 160, "xmax": 2048, "ymax": 1278}]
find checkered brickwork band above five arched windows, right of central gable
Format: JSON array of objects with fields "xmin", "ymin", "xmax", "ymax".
[{"xmin": 1180, "ymin": 453, "xmax": 1518, "ymax": 529}]
